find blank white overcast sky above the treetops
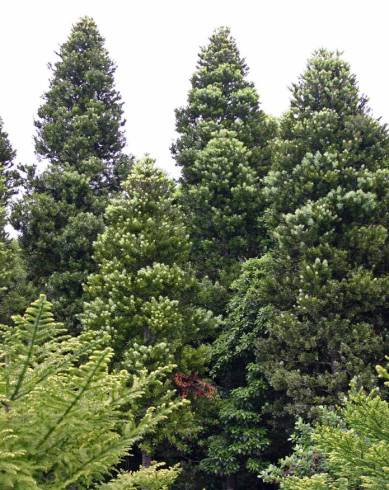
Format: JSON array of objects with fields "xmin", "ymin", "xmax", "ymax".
[{"xmin": 0, "ymin": 0, "xmax": 389, "ymax": 175}]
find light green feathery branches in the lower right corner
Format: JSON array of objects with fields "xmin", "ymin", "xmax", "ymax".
[{"xmin": 263, "ymin": 367, "xmax": 389, "ymax": 490}]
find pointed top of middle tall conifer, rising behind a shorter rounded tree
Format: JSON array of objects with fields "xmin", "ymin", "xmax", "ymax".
[{"xmin": 172, "ymin": 27, "xmax": 274, "ymax": 184}]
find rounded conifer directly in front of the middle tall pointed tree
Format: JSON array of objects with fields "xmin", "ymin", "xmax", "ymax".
[{"xmin": 182, "ymin": 130, "xmax": 263, "ymax": 286}]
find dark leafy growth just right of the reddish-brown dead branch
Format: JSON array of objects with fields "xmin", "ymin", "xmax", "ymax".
[{"xmin": 201, "ymin": 260, "xmax": 269, "ymax": 488}]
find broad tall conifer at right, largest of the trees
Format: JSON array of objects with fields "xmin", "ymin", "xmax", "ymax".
[{"xmin": 229, "ymin": 50, "xmax": 389, "ymax": 422}]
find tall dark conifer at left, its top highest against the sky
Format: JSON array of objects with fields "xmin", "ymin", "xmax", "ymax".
[{"xmin": 13, "ymin": 18, "xmax": 129, "ymax": 330}]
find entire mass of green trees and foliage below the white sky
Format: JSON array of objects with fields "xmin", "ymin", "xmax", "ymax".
[{"xmin": 0, "ymin": 17, "xmax": 389, "ymax": 490}]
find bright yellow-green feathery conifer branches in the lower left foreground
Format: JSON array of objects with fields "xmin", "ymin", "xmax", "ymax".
[{"xmin": 0, "ymin": 295, "xmax": 180, "ymax": 490}]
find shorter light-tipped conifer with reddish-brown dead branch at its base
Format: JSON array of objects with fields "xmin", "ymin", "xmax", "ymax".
[{"xmin": 82, "ymin": 158, "xmax": 215, "ymax": 454}]
